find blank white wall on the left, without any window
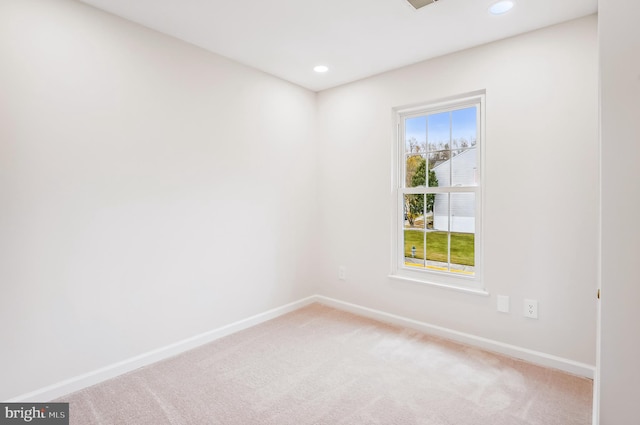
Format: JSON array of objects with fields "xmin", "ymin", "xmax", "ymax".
[{"xmin": 0, "ymin": 0, "xmax": 317, "ymax": 399}]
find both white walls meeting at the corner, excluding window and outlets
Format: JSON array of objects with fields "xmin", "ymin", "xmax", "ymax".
[{"xmin": 0, "ymin": 0, "xmax": 598, "ymax": 399}]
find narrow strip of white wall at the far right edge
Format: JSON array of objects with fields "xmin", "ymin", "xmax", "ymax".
[{"xmin": 596, "ymin": 0, "xmax": 640, "ymax": 425}]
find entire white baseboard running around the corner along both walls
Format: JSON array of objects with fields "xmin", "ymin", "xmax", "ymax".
[{"xmin": 6, "ymin": 295, "xmax": 595, "ymax": 403}]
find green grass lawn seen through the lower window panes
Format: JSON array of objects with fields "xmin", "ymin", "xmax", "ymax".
[{"xmin": 404, "ymin": 230, "xmax": 475, "ymax": 266}]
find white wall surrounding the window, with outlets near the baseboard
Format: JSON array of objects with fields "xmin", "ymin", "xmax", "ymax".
[{"xmin": 318, "ymin": 16, "xmax": 598, "ymax": 365}]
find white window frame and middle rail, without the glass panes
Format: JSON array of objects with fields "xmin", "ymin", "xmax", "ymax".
[{"xmin": 390, "ymin": 90, "xmax": 488, "ymax": 295}]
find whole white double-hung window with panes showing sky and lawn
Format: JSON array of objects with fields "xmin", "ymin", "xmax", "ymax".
[{"xmin": 392, "ymin": 93, "xmax": 484, "ymax": 292}]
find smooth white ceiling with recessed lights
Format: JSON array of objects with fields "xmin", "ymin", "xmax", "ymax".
[{"xmin": 81, "ymin": 0, "xmax": 598, "ymax": 91}]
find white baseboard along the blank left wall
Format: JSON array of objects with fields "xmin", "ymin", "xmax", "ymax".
[{"xmin": 6, "ymin": 296, "xmax": 317, "ymax": 403}]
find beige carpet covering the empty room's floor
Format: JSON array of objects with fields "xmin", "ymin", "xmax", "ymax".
[{"xmin": 57, "ymin": 304, "xmax": 592, "ymax": 425}]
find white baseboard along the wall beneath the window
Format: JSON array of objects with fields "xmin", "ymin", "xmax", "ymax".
[{"xmin": 315, "ymin": 295, "xmax": 595, "ymax": 379}]
